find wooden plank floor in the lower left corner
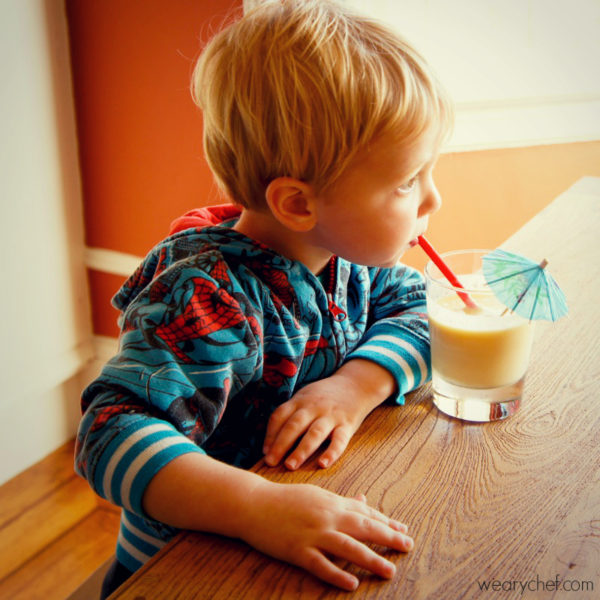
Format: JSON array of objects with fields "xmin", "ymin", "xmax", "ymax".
[{"xmin": 0, "ymin": 440, "xmax": 120, "ymax": 600}]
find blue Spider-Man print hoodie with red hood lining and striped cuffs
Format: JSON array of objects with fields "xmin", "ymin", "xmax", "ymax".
[{"xmin": 76, "ymin": 205, "xmax": 430, "ymax": 571}]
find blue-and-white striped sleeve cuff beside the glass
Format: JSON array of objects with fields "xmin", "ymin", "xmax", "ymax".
[{"xmin": 348, "ymin": 334, "xmax": 430, "ymax": 404}]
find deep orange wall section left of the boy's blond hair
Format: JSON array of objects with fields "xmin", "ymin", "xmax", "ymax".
[{"xmin": 65, "ymin": 0, "xmax": 242, "ymax": 255}]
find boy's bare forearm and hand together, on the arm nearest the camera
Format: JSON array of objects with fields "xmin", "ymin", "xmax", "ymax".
[{"xmin": 143, "ymin": 454, "xmax": 413, "ymax": 590}]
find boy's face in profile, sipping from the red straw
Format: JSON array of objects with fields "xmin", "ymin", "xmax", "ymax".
[{"xmin": 312, "ymin": 128, "xmax": 441, "ymax": 267}]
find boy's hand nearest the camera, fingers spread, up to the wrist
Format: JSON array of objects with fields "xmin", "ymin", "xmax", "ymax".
[{"xmin": 241, "ymin": 480, "xmax": 413, "ymax": 591}]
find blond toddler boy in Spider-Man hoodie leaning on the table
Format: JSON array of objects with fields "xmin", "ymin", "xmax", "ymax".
[{"xmin": 76, "ymin": 0, "xmax": 451, "ymax": 596}]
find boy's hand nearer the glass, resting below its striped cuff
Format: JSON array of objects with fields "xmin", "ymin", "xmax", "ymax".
[{"xmin": 263, "ymin": 360, "xmax": 394, "ymax": 469}]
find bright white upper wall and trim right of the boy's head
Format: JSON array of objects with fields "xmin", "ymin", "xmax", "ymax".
[{"xmin": 343, "ymin": 0, "xmax": 600, "ymax": 151}]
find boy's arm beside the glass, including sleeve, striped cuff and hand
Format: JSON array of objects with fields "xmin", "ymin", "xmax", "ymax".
[{"xmin": 263, "ymin": 266, "xmax": 430, "ymax": 469}]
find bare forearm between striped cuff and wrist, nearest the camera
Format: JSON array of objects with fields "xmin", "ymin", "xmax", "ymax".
[{"xmin": 143, "ymin": 453, "xmax": 269, "ymax": 538}]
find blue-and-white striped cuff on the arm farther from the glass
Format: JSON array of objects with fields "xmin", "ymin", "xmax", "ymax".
[{"xmin": 94, "ymin": 419, "xmax": 206, "ymax": 515}]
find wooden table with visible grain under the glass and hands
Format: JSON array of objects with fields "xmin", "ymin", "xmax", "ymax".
[{"xmin": 111, "ymin": 177, "xmax": 600, "ymax": 600}]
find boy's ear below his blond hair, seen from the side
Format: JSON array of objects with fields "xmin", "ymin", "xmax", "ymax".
[{"xmin": 265, "ymin": 177, "xmax": 317, "ymax": 232}]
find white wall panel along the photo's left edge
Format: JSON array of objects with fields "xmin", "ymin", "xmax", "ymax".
[{"xmin": 0, "ymin": 0, "xmax": 92, "ymax": 483}]
